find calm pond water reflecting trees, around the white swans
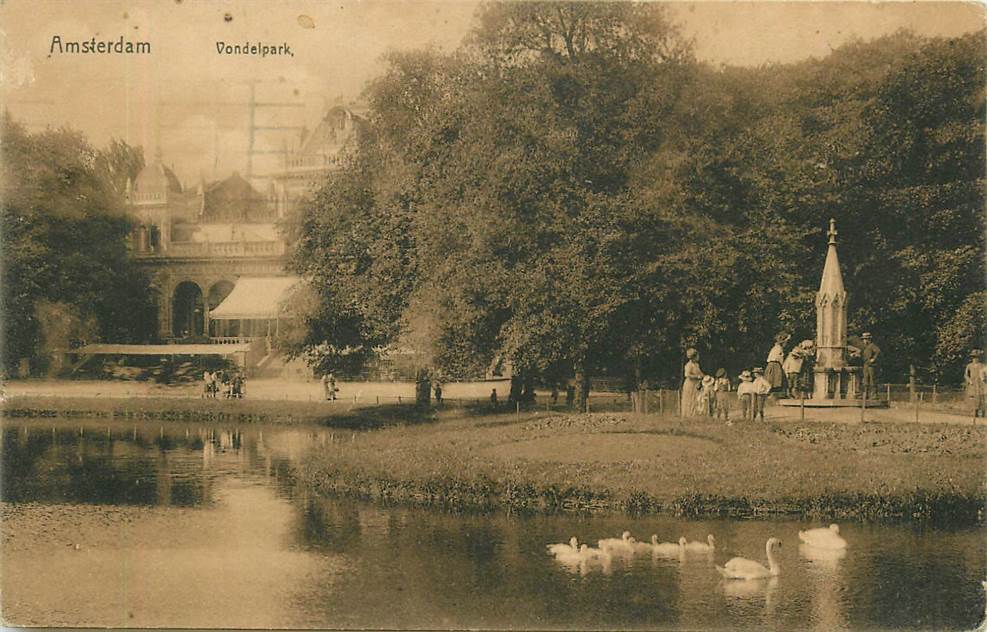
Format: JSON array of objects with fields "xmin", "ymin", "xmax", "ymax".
[{"xmin": 0, "ymin": 419, "xmax": 987, "ymax": 630}]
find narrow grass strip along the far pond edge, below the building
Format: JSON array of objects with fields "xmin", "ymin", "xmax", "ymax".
[{"xmin": 0, "ymin": 396, "xmax": 428, "ymax": 430}]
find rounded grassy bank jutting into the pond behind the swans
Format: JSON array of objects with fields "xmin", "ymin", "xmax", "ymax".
[{"xmin": 300, "ymin": 413, "xmax": 987, "ymax": 524}]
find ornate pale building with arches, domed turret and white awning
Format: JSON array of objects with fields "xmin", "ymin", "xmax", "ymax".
[{"xmin": 127, "ymin": 107, "xmax": 362, "ymax": 350}]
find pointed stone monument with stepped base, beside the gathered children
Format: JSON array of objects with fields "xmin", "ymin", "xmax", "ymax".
[{"xmin": 779, "ymin": 219, "xmax": 887, "ymax": 408}]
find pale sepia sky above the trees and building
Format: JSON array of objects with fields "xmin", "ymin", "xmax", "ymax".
[{"xmin": 0, "ymin": 0, "xmax": 985, "ymax": 185}]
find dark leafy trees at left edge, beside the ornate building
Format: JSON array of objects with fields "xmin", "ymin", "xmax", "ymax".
[{"xmin": 0, "ymin": 115, "xmax": 155, "ymax": 370}]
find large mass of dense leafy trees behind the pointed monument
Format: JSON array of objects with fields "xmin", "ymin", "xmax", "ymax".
[{"xmin": 292, "ymin": 3, "xmax": 987, "ymax": 390}]
